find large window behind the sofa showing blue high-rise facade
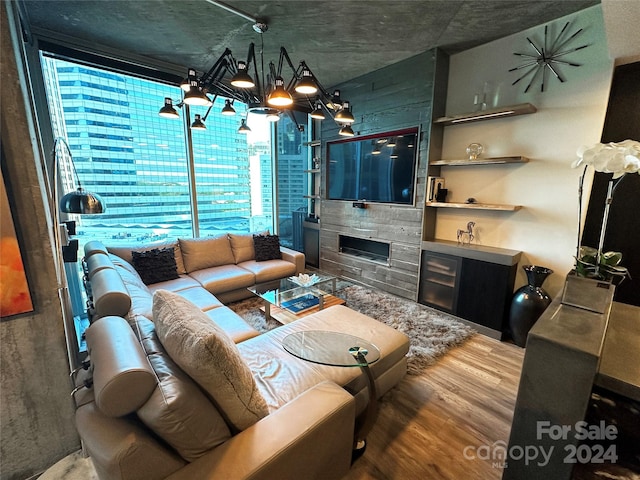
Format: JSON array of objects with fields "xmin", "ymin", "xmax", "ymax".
[{"xmin": 41, "ymin": 54, "xmax": 273, "ymax": 248}]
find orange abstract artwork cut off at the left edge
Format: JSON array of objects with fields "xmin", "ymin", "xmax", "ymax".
[{"xmin": 0, "ymin": 171, "xmax": 33, "ymax": 317}]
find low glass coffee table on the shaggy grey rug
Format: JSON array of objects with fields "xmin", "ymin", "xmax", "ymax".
[{"xmin": 249, "ymin": 272, "xmax": 351, "ymax": 324}]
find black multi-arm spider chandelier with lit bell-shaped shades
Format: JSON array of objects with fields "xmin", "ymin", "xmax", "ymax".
[{"xmin": 159, "ymin": 12, "xmax": 355, "ymax": 136}]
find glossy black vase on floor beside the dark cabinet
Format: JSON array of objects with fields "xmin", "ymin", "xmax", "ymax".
[{"xmin": 509, "ymin": 265, "xmax": 553, "ymax": 347}]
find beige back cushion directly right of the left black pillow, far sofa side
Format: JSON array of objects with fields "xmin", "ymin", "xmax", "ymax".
[{"xmin": 180, "ymin": 237, "xmax": 236, "ymax": 273}]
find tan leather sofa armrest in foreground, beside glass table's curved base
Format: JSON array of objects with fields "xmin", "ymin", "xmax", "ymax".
[{"xmin": 167, "ymin": 382, "xmax": 355, "ymax": 480}]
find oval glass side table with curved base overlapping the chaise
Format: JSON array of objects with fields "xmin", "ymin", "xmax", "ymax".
[{"xmin": 282, "ymin": 330, "xmax": 380, "ymax": 460}]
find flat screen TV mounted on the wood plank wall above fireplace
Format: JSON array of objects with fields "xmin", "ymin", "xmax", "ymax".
[{"xmin": 326, "ymin": 128, "xmax": 419, "ymax": 205}]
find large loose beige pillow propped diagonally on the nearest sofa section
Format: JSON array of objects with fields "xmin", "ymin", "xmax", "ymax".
[{"xmin": 153, "ymin": 290, "xmax": 269, "ymax": 431}]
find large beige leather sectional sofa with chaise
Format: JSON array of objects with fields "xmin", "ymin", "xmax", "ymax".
[{"xmin": 75, "ymin": 235, "xmax": 409, "ymax": 480}]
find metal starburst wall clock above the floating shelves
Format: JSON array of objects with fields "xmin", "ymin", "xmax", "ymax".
[{"xmin": 509, "ymin": 22, "xmax": 589, "ymax": 93}]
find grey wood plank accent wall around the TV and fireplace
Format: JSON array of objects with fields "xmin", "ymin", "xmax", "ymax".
[{"xmin": 320, "ymin": 49, "xmax": 449, "ymax": 301}]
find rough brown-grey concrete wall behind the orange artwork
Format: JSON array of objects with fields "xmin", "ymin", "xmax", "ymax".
[{"xmin": 0, "ymin": 2, "xmax": 80, "ymax": 480}]
